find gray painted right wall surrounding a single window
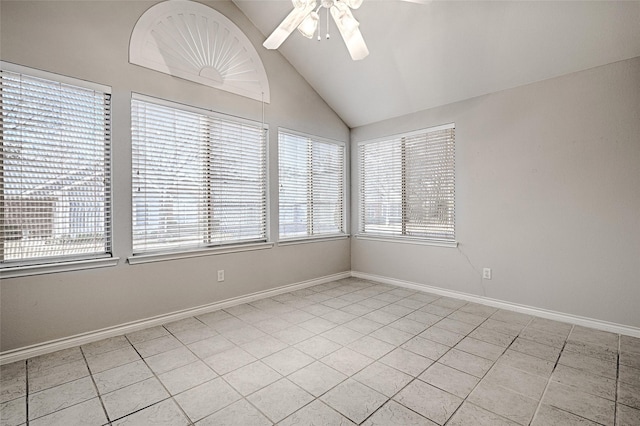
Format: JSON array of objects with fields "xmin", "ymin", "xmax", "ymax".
[{"xmin": 351, "ymin": 58, "xmax": 640, "ymax": 327}]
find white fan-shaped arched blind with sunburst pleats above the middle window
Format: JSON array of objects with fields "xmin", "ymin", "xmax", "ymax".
[{"xmin": 129, "ymin": 0, "xmax": 270, "ymax": 103}]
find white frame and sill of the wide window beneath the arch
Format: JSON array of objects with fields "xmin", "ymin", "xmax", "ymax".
[{"xmin": 127, "ymin": 92, "xmax": 274, "ymax": 265}]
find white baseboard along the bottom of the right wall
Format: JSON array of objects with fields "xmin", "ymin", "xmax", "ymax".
[{"xmin": 351, "ymin": 271, "xmax": 640, "ymax": 338}]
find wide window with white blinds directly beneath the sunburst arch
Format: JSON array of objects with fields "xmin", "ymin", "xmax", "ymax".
[{"xmin": 131, "ymin": 95, "xmax": 267, "ymax": 254}]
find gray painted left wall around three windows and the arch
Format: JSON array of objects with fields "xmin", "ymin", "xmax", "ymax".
[{"xmin": 0, "ymin": 0, "xmax": 350, "ymax": 351}]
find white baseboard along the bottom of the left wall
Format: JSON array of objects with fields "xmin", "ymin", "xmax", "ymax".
[{"xmin": 0, "ymin": 271, "xmax": 351, "ymax": 365}]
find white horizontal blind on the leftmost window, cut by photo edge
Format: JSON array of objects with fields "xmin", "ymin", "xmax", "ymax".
[{"xmin": 0, "ymin": 66, "xmax": 111, "ymax": 267}]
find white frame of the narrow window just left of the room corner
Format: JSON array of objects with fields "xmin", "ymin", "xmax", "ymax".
[{"xmin": 278, "ymin": 127, "xmax": 350, "ymax": 245}]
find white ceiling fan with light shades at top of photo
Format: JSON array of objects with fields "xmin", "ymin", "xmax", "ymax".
[{"xmin": 263, "ymin": 0, "xmax": 369, "ymax": 61}]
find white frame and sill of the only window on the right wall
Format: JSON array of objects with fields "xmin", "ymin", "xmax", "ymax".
[{"xmin": 355, "ymin": 123, "xmax": 458, "ymax": 248}]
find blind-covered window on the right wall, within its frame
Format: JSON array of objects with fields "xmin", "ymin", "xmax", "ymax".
[{"xmin": 359, "ymin": 125, "xmax": 455, "ymax": 242}]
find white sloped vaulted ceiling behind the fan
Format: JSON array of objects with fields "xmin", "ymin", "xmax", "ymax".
[{"xmin": 233, "ymin": 0, "xmax": 640, "ymax": 128}]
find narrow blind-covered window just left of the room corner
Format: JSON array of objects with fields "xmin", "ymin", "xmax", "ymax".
[{"xmin": 278, "ymin": 131, "xmax": 345, "ymax": 239}]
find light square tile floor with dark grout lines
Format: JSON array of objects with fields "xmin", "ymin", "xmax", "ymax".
[{"xmin": 0, "ymin": 279, "xmax": 640, "ymax": 426}]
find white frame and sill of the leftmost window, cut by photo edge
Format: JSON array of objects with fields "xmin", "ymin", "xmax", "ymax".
[{"xmin": 0, "ymin": 61, "xmax": 119, "ymax": 278}]
